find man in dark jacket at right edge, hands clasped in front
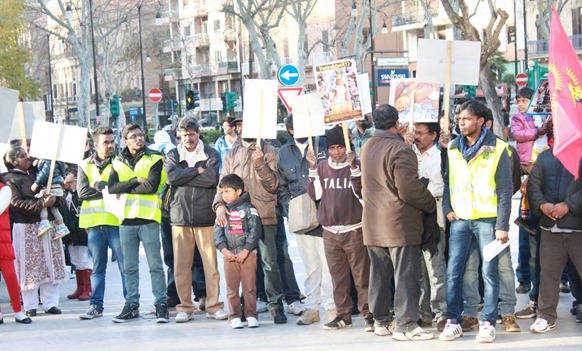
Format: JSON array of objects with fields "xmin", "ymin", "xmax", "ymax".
[{"xmin": 527, "ymin": 149, "xmax": 582, "ymax": 333}]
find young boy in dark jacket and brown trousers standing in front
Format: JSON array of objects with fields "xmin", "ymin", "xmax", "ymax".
[{"xmin": 214, "ymin": 174, "xmax": 261, "ymax": 329}]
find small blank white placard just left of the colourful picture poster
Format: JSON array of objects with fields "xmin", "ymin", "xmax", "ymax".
[{"xmin": 292, "ymin": 93, "xmax": 325, "ymax": 139}]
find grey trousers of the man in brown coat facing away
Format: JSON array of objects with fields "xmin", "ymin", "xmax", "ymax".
[{"xmin": 368, "ymin": 246, "xmax": 421, "ymax": 333}]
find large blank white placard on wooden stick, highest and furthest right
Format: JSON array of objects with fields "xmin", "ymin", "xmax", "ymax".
[{"xmin": 416, "ymin": 39, "xmax": 481, "ymax": 85}]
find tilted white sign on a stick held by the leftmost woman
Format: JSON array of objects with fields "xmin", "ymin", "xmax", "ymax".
[{"xmin": 30, "ymin": 121, "xmax": 87, "ymax": 164}]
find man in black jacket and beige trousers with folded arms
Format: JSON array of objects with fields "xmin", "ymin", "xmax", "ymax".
[{"xmin": 164, "ymin": 117, "xmax": 228, "ymax": 323}]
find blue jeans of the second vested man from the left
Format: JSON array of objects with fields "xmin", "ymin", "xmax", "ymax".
[{"xmin": 119, "ymin": 223, "xmax": 166, "ymax": 307}]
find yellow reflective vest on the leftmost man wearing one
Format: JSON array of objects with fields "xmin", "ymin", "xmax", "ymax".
[{"xmin": 79, "ymin": 159, "xmax": 120, "ymax": 228}]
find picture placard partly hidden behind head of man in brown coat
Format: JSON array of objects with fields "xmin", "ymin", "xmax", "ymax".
[{"xmin": 389, "ymin": 78, "xmax": 440, "ymax": 124}]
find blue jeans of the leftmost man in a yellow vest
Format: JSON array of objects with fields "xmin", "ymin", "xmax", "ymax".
[{"xmin": 87, "ymin": 225, "xmax": 127, "ymax": 311}]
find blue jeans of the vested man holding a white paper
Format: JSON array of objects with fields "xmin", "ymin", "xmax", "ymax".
[{"xmin": 447, "ymin": 218, "xmax": 499, "ymax": 325}]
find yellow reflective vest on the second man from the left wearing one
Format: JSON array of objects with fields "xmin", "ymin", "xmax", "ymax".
[{"xmin": 113, "ymin": 154, "xmax": 166, "ymax": 223}]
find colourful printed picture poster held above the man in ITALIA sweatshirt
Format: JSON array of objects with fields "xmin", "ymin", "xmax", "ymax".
[{"xmin": 314, "ymin": 60, "xmax": 364, "ymax": 124}]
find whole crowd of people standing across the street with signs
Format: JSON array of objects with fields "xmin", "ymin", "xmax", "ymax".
[{"xmin": 0, "ymin": 97, "xmax": 582, "ymax": 343}]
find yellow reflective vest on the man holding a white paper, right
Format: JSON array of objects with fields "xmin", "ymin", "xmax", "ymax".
[{"xmin": 448, "ymin": 139, "xmax": 507, "ymax": 220}]
